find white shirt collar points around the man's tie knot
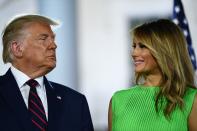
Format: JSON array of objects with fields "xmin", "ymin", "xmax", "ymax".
[{"xmin": 11, "ymin": 66, "xmax": 44, "ymax": 88}]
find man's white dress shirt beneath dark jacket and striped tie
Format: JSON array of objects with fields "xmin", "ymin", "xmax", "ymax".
[{"xmin": 11, "ymin": 66, "xmax": 48, "ymax": 119}]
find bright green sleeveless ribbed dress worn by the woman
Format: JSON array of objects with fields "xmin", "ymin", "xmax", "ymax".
[{"xmin": 112, "ymin": 85, "xmax": 197, "ymax": 131}]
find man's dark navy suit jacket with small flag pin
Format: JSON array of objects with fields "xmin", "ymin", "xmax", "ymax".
[{"xmin": 0, "ymin": 69, "xmax": 93, "ymax": 131}]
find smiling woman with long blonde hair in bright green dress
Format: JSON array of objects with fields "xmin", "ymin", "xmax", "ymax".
[{"xmin": 108, "ymin": 19, "xmax": 197, "ymax": 131}]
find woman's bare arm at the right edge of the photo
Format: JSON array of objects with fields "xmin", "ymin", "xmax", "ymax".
[{"xmin": 188, "ymin": 95, "xmax": 197, "ymax": 131}]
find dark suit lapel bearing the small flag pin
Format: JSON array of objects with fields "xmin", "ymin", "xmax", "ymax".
[{"xmin": 44, "ymin": 77, "xmax": 62, "ymax": 131}]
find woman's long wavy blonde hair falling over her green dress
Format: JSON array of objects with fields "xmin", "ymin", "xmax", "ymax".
[{"xmin": 133, "ymin": 19, "xmax": 194, "ymax": 117}]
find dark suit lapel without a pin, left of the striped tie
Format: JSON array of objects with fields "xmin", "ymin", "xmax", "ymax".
[{"xmin": 2, "ymin": 69, "xmax": 32, "ymax": 131}]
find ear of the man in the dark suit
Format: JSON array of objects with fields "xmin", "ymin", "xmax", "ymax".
[{"xmin": 11, "ymin": 41, "xmax": 23, "ymax": 57}]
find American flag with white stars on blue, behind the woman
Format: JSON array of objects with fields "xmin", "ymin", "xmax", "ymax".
[{"xmin": 172, "ymin": 0, "xmax": 197, "ymax": 70}]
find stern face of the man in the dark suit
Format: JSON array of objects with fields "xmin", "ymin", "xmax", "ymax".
[{"xmin": 21, "ymin": 23, "xmax": 57, "ymax": 75}]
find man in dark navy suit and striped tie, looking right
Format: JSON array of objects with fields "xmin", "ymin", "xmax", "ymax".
[{"xmin": 0, "ymin": 15, "xmax": 93, "ymax": 131}]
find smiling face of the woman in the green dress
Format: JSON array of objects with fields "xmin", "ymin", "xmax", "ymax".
[{"xmin": 132, "ymin": 38, "xmax": 160, "ymax": 75}]
